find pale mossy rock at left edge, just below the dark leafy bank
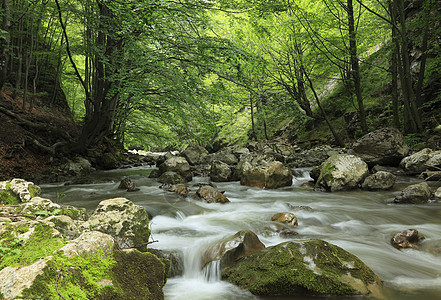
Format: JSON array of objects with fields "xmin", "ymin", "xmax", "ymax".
[{"xmin": 0, "ymin": 178, "xmax": 41, "ymax": 204}]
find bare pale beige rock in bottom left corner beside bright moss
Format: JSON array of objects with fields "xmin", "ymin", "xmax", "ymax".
[{"xmin": 0, "ymin": 256, "xmax": 52, "ymax": 299}]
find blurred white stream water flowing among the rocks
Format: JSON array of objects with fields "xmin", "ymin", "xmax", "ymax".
[{"xmin": 41, "ymin": 167, "xmax": 441, "ymax": 300}]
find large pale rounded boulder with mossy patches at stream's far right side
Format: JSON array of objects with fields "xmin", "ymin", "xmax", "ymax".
[{"xmin": 316, "ymin": 154, "xmax": 369, "ymax": 192}]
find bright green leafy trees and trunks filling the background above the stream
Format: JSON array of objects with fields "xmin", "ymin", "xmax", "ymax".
[{"xmin": 0, "ymin": 0, "xmax": 441, "ymax": 152}]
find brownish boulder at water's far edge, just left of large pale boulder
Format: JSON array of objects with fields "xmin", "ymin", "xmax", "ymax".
[{"xmin": 240, "ymin": 161, "xmax": 292, "ymax": 189}]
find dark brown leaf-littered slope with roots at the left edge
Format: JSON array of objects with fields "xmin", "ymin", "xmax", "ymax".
[{"xmin": 0, "ymin": 89, "xmax": 81, "ymax": 180}]
